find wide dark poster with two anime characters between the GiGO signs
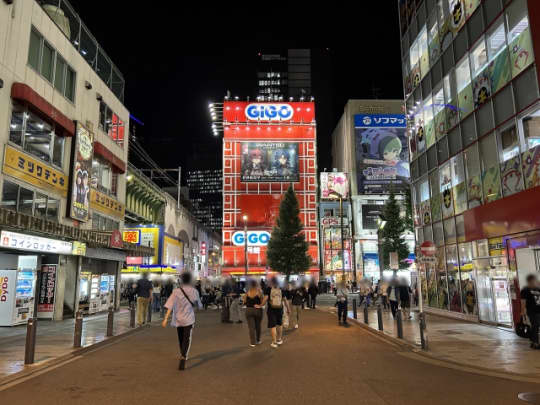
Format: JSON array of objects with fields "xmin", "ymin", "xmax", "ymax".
[{"xmin": 241, "ymin": 142, "xmax": 299, "ymax": 182}]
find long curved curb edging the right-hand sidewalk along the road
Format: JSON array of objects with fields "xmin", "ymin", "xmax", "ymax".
[{"xmin": 317, "ymin": 308, "xmax": 540, "ymax": 384}]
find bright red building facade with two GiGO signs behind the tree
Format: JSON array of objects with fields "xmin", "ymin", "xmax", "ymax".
[{"xmin": 222, "ymin": 101, "xmax": 319, "ymax": 276}]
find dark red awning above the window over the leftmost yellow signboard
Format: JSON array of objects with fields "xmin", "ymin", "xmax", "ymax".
[{"xmin": 11, "ymin": 83, "xmax": 75, "ymax": 136}]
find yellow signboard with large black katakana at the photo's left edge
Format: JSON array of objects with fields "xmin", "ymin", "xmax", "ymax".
[{"xmin": 3, "ymin": 145, "xmax": 68, "ymax": 197}]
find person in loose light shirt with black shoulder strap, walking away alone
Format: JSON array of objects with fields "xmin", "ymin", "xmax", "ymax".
[{"xmin": 161, "ymin": 272, "xmax": 202, "ymax": 370}]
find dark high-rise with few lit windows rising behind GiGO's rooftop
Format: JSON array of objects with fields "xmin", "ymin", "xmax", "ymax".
[{"xmin": 257, "ymin": 49, "xmax": 311, "ymax": 101}]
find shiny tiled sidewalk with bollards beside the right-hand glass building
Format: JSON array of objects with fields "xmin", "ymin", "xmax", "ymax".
[{"xmin": 320, "ymin": 294, "xmax": 540, "ymax": 378}]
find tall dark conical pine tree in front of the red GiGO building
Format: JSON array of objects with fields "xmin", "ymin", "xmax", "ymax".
[{"xmin": 266, "ymin": 185, "xmax": 311, "ymax": 280}]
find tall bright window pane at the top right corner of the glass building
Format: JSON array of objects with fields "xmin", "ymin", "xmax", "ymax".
[{"xmin": 506, "ymin": 0, "xmax": 534, "ymax": 77}]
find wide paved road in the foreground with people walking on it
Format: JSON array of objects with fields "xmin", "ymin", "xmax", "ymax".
[{"xmin": 0, "ymin": 310, "xmax": 540, "ymax": 405}]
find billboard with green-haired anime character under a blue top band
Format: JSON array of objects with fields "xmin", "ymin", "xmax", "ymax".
[{"xmin": 354, "ymin": 114, "xmax": 410, "ymax": 194}]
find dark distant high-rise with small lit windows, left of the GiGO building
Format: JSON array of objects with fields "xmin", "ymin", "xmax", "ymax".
[{"xmin": 187, "ymin": 169, "xmax": 223, "ymax": 232}]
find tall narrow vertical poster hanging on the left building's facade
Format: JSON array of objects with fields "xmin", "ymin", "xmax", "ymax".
[{"xmin": 69, "ymin": 123, "xmax": 94, "ymax": 222}]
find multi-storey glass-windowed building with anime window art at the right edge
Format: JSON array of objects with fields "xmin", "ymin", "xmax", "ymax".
[{"xmin": 398, "ymin": 0, "xmax": 540, "ymax": 326}]
